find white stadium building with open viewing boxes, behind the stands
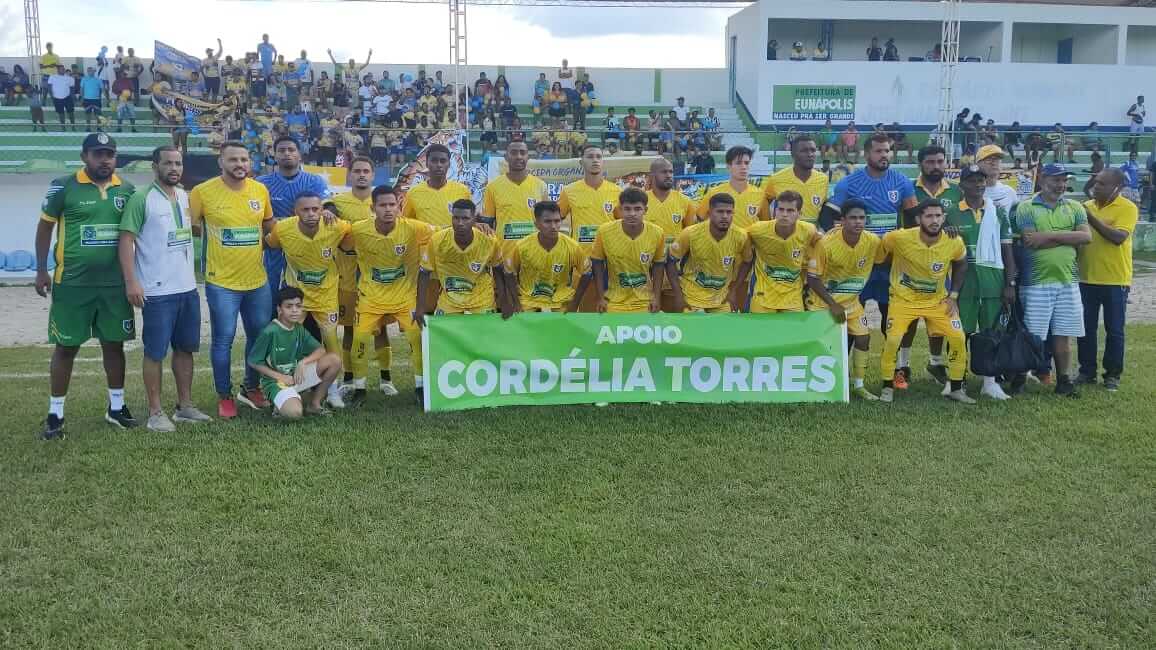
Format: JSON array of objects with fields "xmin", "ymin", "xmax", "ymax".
[{"xmin": 726, "ymin": 0, "xmax": 1156, "ymax": 130}]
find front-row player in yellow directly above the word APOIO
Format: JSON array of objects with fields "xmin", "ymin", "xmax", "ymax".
[{"xmin": 590, "ymin": 187, "xmax": 668, "ymax": 313}]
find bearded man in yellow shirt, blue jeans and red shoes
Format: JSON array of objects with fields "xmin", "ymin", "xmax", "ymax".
[{"xmin": 188, "ymin": 141, "xmax": 274, "ymax": 419}]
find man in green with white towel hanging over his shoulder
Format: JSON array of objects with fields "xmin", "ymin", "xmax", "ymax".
[{"xmin": 944, "ymin": 164, "xmax": 1016, "ymax": 400}]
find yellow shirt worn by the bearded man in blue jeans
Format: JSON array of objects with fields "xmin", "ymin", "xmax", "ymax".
[{"xmin": 188, "ymin": 177, "xmax": 273, "ymax": 291}]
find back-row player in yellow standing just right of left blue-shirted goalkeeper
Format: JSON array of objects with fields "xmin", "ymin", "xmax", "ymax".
[{"xmin": 333, "ymin": 156, "xmax": 381, "ymax": 394}]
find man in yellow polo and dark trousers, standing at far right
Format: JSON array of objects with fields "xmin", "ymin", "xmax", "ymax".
[{"xmin": 1076, "ymin": 169, "xmax": 1140, "ymax": 391}]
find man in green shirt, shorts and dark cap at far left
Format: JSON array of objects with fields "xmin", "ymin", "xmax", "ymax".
[{"xmin": 36, "ymin": 133, "xmax": 136, "ymax": 440}]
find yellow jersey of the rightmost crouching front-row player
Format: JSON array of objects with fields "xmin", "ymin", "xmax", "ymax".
[{"xmin": 876, "ymin": 228, "xmax": 968, "ymax": 308}]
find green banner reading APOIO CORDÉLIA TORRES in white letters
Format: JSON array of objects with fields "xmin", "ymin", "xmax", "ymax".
[{"xmin": 422, "ymin": 311, "xmax": 849, "ymax": 411}]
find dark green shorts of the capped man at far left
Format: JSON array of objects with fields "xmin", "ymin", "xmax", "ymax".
[{"xmin": 49, "ymin": 285, "xmax": 136, "ymax": 347}]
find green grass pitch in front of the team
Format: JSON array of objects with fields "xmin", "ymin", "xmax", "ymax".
[{"xmin": 0, "ymin": 326, "xmax": 1156, "ymax": 648}]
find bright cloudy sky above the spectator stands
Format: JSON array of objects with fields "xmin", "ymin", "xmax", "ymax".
[{"xmin": 0, "ymin": 0, "xmax": 739, "ymax": 67}]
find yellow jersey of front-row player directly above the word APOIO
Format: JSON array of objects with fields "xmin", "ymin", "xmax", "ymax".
[{"xmin": 590, "ymin": 221, "xmax": 666, "ymax": 311}]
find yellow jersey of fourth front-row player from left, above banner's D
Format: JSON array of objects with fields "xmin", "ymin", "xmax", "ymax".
[{"xmin": 505, "ymin": 232, "xmax": 590, "ymax": 310}]
